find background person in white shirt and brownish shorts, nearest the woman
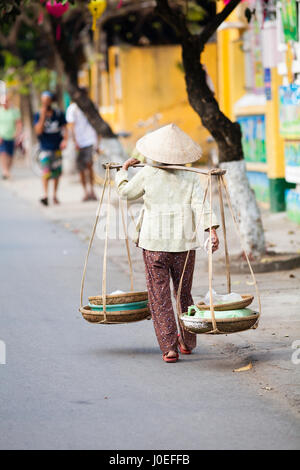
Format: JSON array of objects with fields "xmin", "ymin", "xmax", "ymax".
[{"xmin": 66, "ymin": 89, "xmax": 98, "ymax": 201}]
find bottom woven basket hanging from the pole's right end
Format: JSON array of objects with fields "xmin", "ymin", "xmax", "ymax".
[{"xmin": 180, "ymin": 313, "xmax": 260, "ymax": 334}]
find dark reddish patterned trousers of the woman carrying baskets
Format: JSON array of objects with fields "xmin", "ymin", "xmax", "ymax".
[{"xmin": 143, "ymin": 250, "xmax": 196, "ymax": 354}]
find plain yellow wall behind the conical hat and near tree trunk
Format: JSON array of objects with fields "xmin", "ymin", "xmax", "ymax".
[{"xmin": 100, "ymin": 43, "xmax": 217, "ymax": 156}]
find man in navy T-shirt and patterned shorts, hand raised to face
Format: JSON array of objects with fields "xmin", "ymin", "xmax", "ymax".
[{"xmin": 34, "ymin": 91, "xmax": 68, "ymax": 206}]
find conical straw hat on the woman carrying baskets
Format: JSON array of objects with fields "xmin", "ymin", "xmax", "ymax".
[{"xmin": 136, "ymin": 124, "xmax": 201, "ymax": 165}]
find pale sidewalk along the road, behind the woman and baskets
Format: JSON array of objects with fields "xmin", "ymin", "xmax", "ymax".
[{"xmin": 3, "ymin": 162, "xmax": 300, "ymax": 413}]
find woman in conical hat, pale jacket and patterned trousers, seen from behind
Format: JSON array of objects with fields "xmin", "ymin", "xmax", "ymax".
[{"xmin": 116, "ymin": 124, "xmax": 219, "ymax": 362}]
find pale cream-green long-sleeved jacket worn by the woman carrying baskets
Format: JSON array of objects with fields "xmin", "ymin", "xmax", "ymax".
[{"xmin": 115, "ymin": 166, "xmax": 218, "ymax": 252}]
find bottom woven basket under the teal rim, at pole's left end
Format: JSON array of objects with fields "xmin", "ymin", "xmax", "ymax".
[{"xmin": 79, "ymin": 305, "xmax": 150, "ymax": 325}]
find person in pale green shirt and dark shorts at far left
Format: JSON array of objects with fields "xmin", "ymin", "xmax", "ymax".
[{"xmin": 0, "ymin": 96, "xmax": 22, "ymax": 179}]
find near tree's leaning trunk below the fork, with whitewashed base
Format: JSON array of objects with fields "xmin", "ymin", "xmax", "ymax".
[{"xmin": 182, "ymin": 36, "xmax": 265, "ymax": 257}]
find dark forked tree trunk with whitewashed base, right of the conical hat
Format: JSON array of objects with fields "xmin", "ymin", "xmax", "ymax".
[{"xmin": 156, "ymin": 0, "xmax": 265, "ymax": 256}]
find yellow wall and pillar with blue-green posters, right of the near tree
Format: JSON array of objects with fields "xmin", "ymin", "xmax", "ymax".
[{"xmin": 217, "ymin": 2, "xmax": 291, "ymax": 212}]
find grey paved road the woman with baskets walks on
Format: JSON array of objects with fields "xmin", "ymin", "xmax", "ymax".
[{"xmin": 0, "ymin": 182, "xmax": 300, "ymax": 449}]
